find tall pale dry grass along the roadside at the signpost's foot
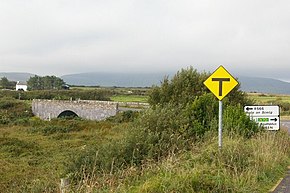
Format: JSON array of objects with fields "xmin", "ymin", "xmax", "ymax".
[{"xmin": 74, "ymin": 131, "xmax": 290, "ymax": 193}]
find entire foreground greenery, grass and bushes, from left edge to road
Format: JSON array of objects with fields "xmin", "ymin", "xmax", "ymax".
[{"xmin": 0, "ymin": 68, "xmax": 290, "ymax": 193}]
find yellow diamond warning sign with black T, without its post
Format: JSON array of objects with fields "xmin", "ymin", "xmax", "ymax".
[{"xmin": 203, "ymin": 66, "xmax": 239, "ymax": 100}]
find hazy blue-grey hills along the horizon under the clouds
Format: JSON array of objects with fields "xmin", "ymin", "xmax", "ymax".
[{"xmin": 0, "ymin": 72, "xmax": 290, "ymax": 94}]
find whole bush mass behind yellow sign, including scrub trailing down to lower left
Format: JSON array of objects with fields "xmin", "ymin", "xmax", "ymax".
[{"xmin": 68, "ymin": 68, "xmax": 260, "ymax": 185}]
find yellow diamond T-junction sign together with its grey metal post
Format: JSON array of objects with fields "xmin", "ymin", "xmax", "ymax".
[{"xmin": 203, "ymin": 66, "xmax": 239, "ymax": 149}]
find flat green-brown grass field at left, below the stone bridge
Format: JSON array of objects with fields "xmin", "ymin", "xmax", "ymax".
[{"xmin": 0, "ymin": 119, "xmax": 121, "ymax": 193}]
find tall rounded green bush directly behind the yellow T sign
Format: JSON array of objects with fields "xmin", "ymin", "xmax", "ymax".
[{"xmin": 145, "ymin": 67, "xmax": 259, "ymax": 140}]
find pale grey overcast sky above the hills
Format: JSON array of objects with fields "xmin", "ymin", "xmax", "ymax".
[{"xmin": 0, "ymin": 0, "xmax": 290, "ymax": 80}]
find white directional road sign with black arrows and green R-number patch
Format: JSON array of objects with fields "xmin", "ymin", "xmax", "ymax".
[{"xmin": 244, "ymin": 106, "xmax": 280, "ymax": 130}]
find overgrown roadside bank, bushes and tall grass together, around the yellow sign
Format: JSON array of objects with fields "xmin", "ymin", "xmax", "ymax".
[{"xmin": 68, "ymin": 68, "xmax": 290, "ymax": 192}]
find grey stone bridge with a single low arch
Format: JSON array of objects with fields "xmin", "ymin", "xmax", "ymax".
[{"xmin": 32, "ymin": 99, "xmax": 118, "ymax": 121}]
